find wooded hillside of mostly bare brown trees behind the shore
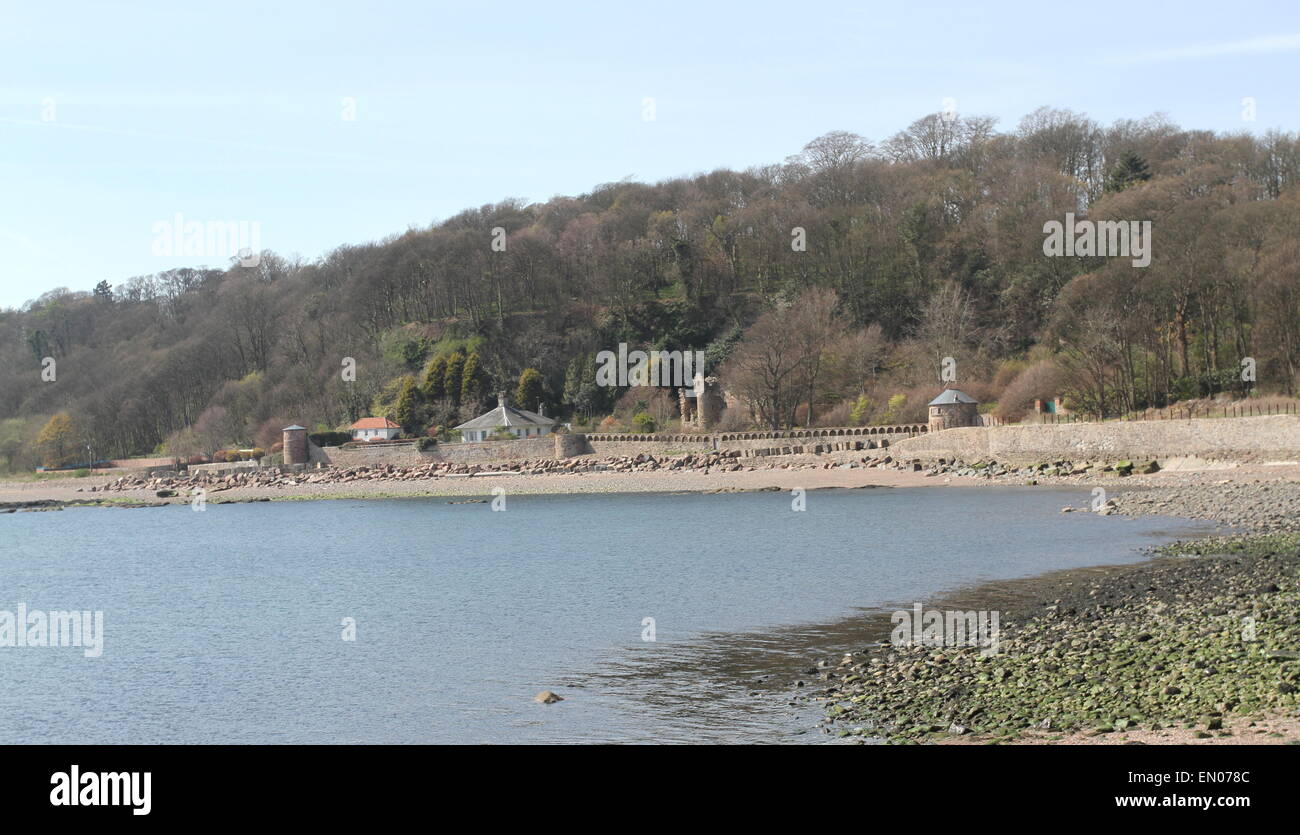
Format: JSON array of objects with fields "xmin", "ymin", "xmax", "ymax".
[{"xmin": 0, "ymin": 108, "xmax": 1300, "ymax": 471}]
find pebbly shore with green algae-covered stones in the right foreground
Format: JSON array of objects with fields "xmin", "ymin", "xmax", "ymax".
[{"xmin": 806, "ymin": 473, "xmax": 1300, "ymax": 743}]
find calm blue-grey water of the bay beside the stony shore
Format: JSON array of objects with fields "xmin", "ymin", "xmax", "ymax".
[{"xmin": 0, "ymin": 488, "xmax": 1211, "ymax": 743}]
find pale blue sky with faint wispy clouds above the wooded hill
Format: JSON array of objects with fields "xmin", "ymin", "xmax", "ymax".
[{"xmin": 0, "ymin": 0, "xmax": 1300, "ymax": 308}]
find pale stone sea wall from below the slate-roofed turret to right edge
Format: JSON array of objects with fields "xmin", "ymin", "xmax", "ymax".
[{"xmin": 892, "ymin": 415, "xmax": 1300, "ymax": 464}]
